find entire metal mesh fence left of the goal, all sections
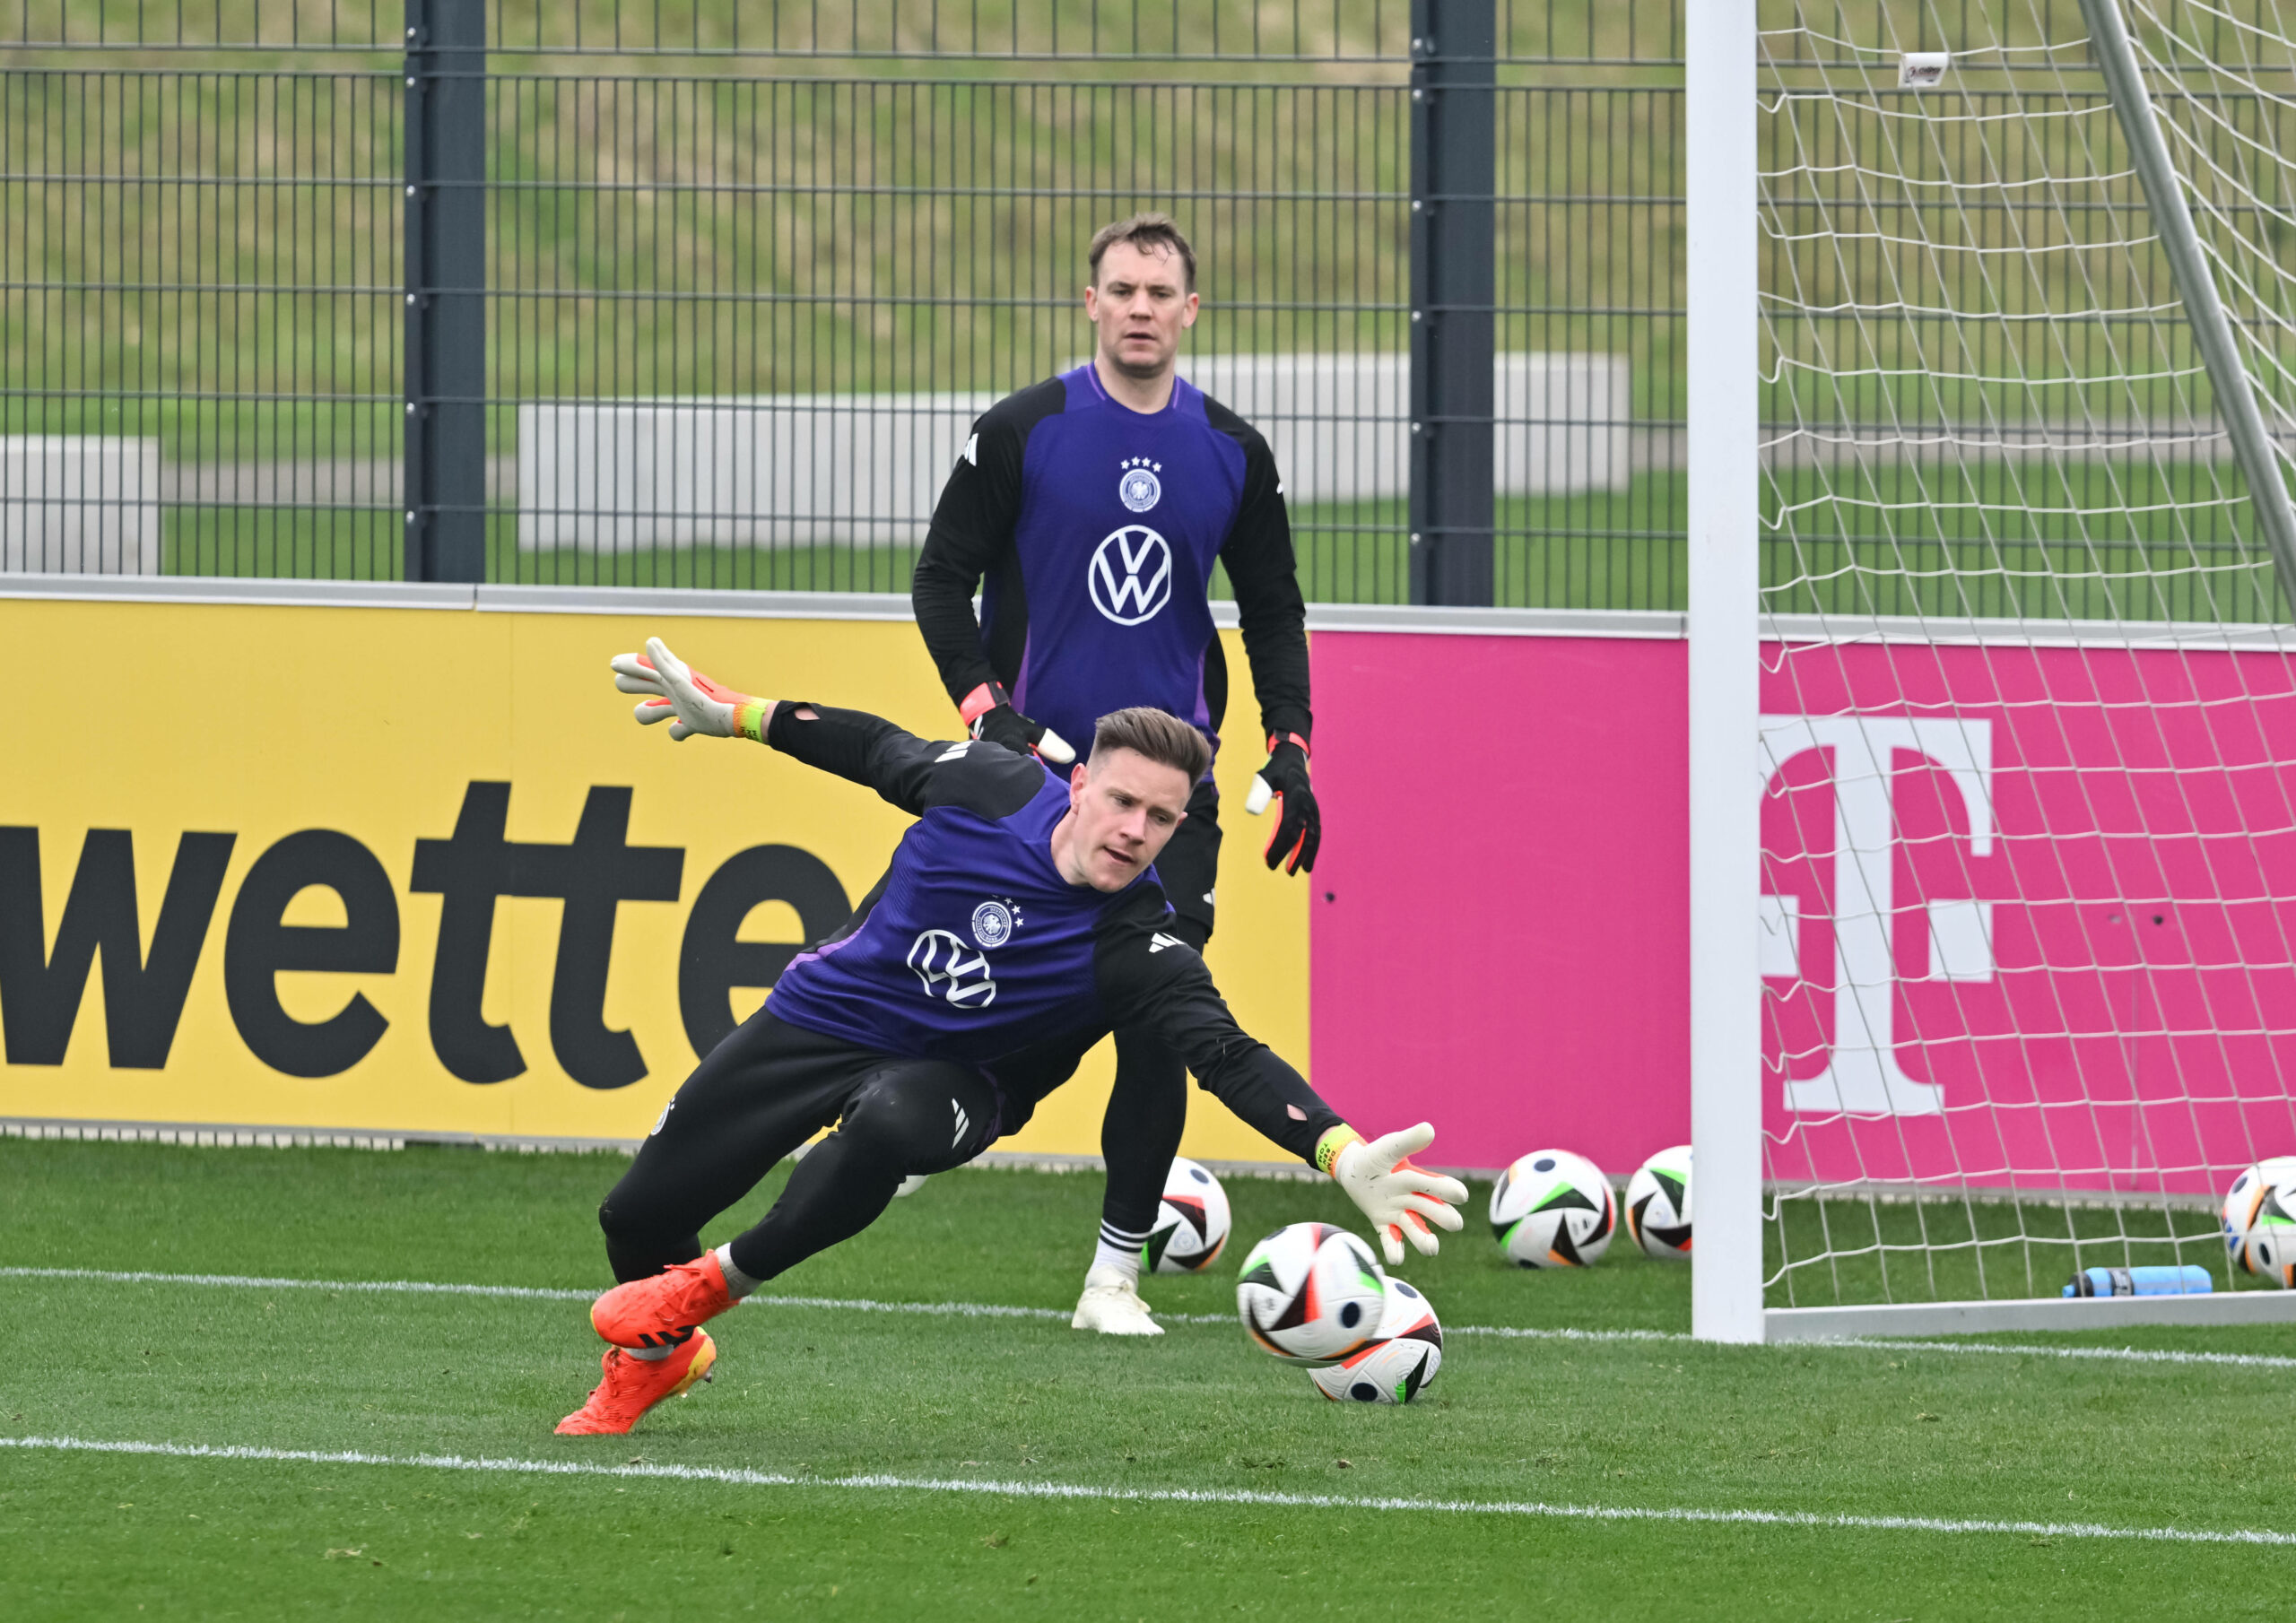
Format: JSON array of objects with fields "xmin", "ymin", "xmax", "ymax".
[{"xmin": 0, "ymin": 0, "xmax": 1790, "ymax": 608}]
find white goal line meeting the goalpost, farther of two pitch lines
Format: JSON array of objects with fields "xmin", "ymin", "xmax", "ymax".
[{"xmin": 0, "ymin": 1267, "xmax": 2296, "ymax": 1370}]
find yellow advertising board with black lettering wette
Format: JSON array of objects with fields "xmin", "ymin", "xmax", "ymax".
[{"xmin": 0, "ymin": 593, "xmax": 1309, "ymax": 1161}]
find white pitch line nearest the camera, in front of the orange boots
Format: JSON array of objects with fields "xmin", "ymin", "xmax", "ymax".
[{"xmin": 0, "ymin": 1437, "xmax": 2296, "ymax": 1548}]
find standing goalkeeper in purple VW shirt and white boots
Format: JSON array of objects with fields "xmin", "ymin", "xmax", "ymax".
[{"xmin": 911, "ymin": 213, "xmax": 1323, "ymax": 1336}]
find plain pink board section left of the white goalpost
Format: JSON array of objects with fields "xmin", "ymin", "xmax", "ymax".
[{"xmin": 1309, "ymin": 631, "xmax": 1690, "ymax": 1171}]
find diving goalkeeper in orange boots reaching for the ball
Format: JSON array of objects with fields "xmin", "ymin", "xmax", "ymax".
[{"xmin": 558, "ymin": 638, "xmax": 1467, "ymax": 1435}]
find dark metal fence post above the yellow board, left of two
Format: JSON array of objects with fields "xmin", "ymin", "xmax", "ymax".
[{"xmin": 404, "ymin": 0, "xmax": 487, "ymax": 581}]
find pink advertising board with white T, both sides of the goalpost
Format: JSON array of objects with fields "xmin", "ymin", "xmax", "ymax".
[{"xmin": 1311, "ymin": 631, "xmax": 2296, "ymax": 1192}]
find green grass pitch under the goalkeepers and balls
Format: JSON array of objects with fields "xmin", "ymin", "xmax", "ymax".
[{"xmin": 0, "ymin": 1139, "xmax": 2296, "ymax": 1623}]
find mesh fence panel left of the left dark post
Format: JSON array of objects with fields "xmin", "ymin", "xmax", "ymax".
[{"xmin": 0, "ymin": 53, "xmax": 402, "ymax": 577}]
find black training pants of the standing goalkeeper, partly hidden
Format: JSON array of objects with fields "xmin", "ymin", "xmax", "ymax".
[{"xmin": 1100, "ymin": 780, "xmax": 1219, "ymax": 1235}]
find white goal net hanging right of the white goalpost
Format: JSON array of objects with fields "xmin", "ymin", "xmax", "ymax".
[{"xmin": 1735, "ymin": 0, "xmax": 2296, "ymax": 1336}]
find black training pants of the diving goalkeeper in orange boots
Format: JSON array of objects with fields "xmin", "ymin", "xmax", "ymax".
[{"xmin": 597, "ymin": 1001, "xmax": 1001, "ymax": 1281}]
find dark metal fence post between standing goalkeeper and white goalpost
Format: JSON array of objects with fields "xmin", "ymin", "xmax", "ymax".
[{"xmin": 1410, "ymin": 0, "xmax": 1500, "ymax": 603}]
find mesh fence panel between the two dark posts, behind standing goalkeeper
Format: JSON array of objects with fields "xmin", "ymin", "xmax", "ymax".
[{"xmin": 489, "ymin": 75, "xmax": 1407, "ymax": 595}]
